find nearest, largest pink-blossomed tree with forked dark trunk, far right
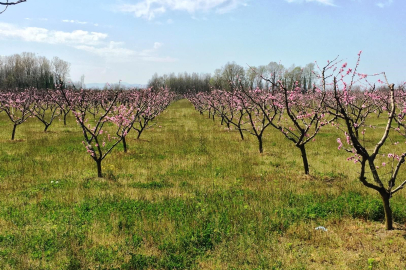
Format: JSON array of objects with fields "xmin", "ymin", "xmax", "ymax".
[{"xmin": 330, "ymin": 52, "xmax": 406, "ymax": 230}]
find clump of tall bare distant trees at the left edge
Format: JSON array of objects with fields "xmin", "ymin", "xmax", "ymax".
[{"xmin": 0, "ymin": 52, "xmax": 70, "ymax": 89}]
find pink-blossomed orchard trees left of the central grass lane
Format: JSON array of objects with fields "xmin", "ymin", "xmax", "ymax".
[{"xmin": 0, "ymin": 88, "xmax": 175, "ymax": 177}]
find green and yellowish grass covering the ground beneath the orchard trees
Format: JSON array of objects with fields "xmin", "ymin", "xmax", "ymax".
[{"xmin": 0, "ymin": 100, "xmax": 406, "ymax": 269}]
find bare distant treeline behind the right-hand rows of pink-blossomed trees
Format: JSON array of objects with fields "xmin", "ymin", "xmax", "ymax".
[{"xmin": 148, "ymin": 62, "xmax": 317, "ymax": 94}]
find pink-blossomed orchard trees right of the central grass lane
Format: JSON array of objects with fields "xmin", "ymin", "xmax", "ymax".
[{"xmin": 187, "ymin": 52, "xmax": 406, "ymax": 230}]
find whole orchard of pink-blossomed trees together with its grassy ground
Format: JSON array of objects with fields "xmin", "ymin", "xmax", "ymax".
[{"xmin": 0, "ymin": 52, "xmax": 406, "ymax": 269}]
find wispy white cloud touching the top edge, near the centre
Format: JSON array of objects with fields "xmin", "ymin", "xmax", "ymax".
[{"xmin": 117, "ymin": 0, "xmax": 247, "ymax": 20}]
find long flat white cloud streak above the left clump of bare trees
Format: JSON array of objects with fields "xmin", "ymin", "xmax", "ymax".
[{"xmin": 0, "ymin": 23, "xmax": 108, "ymax": 45}]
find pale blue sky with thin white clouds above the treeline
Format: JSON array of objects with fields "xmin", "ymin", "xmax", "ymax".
[{"xmin": 0, "ymin": 0, "xmax": 406, "ymax": 84}]
